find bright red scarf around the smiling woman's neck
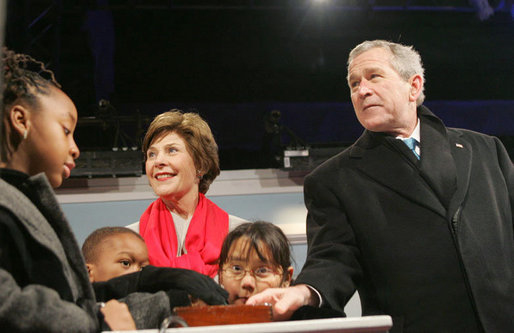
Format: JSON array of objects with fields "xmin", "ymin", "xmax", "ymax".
[{"xmin": 139, "ymin": 193, "xmax": 228, "ymax": 277}]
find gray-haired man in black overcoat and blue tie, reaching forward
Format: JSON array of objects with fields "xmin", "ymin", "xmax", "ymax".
[{"xmin": 247, "ymin": 40, "xmax": 514, "ymax": 333}]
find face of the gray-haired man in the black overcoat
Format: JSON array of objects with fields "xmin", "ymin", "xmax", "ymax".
[{"xmin": 348, "ymin": 48, "xmax": 421, "ymax": 137}]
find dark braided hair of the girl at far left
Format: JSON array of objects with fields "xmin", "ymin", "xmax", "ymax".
[{"xmin": 0, "ymin": 47, "xmax": 61, "ymax": 162}]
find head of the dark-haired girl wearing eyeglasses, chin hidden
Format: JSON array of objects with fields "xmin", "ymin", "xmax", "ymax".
[{"xmin": 219, "ymin": 221, "xmax": 293, "ymax": 304}]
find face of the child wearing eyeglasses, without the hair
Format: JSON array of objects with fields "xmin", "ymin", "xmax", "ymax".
[{"xmin": 219, "ymin": 237, "xmax": 293, "ymax": 304}]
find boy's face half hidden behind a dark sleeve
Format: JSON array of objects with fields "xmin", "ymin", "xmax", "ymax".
[{"xmin": 86, "ymin": 233, "xmax": 148, "ymax": 282}]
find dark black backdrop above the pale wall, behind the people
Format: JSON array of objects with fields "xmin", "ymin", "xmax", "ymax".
[{"xmin": 6, "ymin": 0, "xmax": 514, "ymax": 169}]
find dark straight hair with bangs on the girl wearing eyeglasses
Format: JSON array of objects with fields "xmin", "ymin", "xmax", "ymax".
[{"xmin": 219, "ymin": 221, "xmax": 291, "ymax": 282}]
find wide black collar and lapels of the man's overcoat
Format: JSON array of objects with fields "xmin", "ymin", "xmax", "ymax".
[{"xmin": 349, "ymin": 106, "xmax": 471, "ymax": 217}]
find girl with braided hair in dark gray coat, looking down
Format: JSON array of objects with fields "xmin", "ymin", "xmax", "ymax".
[{"xmin": 0, "ymin": 48, "xmax": 135, "ymax": 332}]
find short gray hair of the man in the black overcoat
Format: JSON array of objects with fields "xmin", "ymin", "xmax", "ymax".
[{"xmin": 347, "ymin": 39, "xmax": 425, "ymax": 106}]
